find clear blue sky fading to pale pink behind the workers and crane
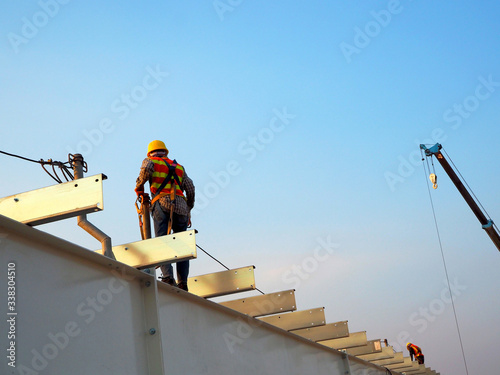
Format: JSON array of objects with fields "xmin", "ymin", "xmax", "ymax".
[{"xmin": 0, "ymin": 0, "xmax": 500, "ymax": 375}]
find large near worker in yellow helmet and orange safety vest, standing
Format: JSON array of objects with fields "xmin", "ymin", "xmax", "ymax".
[{"xmin": 135, "ymin": 140, "xmax": 195, "ymax": 291}]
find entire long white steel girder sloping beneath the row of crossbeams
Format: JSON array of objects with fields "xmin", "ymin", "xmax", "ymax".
[{"xmin": 0, "ymin": 216, "xmax": 410, "ymax": 375}]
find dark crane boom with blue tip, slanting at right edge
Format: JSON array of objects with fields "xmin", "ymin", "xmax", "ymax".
[{"xmin": 420, "ymin": 143, "xmax": 500, "ymax": 251}]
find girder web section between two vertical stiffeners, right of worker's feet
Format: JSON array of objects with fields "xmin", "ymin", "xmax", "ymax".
[{"xmin": 159, "ymin": 285, "xmax": 350, "ymax": 375}]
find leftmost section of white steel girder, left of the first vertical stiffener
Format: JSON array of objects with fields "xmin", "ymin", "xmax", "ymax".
[{"xmin": 0, "ymin": 217, "xmax": 151, "ymax": 375}]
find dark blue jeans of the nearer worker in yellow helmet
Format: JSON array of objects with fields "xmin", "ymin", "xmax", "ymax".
[{"xmin": 152, "ymin": 202, "xmax": 189, "ymax": 283}]
